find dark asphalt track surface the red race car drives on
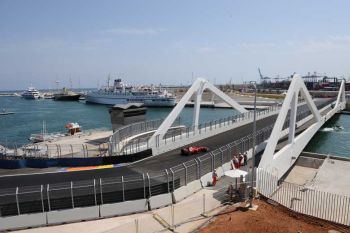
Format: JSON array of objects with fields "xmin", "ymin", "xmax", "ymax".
[{"xmin": 0, "ymin": 99, "xmax": 329, "ymax": 189}]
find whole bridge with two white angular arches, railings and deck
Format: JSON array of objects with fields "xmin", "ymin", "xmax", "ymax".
[{"xmin": 109, "ymin": 75, "xmax": 346, "ymax": 178}]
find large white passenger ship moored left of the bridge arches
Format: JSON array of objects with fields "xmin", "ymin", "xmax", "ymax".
[{"xmin": 85, "ymin": 79, "xmax": 176, "ymax": 107}]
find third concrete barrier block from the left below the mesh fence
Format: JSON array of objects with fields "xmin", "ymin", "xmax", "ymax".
[{"xmin": 100, "ymin": 199, "xmax": 148, "ymax": 217}]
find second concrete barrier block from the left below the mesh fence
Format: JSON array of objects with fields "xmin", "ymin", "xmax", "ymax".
[{"xmin": 47, "ymin": 206, "xmax": 100, "ymax": 224}]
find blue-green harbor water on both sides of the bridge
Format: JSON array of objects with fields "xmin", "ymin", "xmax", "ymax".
[{"xmin": 0, "ymin": 97, "xmax": 350, "ymax": 157}]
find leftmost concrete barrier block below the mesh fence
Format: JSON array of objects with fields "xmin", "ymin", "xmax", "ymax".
[{"xmin": 0, "ymin": 213, "xmax": 46, "ymax": 231}]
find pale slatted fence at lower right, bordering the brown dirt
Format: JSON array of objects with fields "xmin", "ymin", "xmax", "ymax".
[{"xmin": 257, "ymin": 169, "xmax": 350, "ymax": 226}]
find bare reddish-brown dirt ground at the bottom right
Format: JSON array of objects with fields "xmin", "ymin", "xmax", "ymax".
[{"xmin": 198, "ymin": 200, "xmax": 350, "ymax": 233}]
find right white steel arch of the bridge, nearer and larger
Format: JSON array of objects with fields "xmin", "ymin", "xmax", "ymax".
[{"xmin": 259, "ymin": 75, "xmax": 346, "ymax": 178}]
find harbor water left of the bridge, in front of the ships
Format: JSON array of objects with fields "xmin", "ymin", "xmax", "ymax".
[{"xmin": 0, "ymin": 97, "xmax": 238, "ymax": 146}]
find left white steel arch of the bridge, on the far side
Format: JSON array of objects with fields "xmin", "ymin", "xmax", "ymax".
[{"xmin": 151, "ymin": 78, "xmax": 248, "ymax": 141}]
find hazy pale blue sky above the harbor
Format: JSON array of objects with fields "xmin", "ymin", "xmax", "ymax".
[{"xmin": 0, "ymin": 0, "xmax": 350, "ymax": 90}]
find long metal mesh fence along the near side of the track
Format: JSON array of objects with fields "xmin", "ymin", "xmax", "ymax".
[{"xmin": 0, "ymin": 98, "xmax": 336, "ymax": 216}]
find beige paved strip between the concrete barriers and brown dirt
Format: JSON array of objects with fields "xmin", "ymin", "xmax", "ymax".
[{"xmin": 104, "ymin": 182, "xmax": 249, "ymax": 233}]
